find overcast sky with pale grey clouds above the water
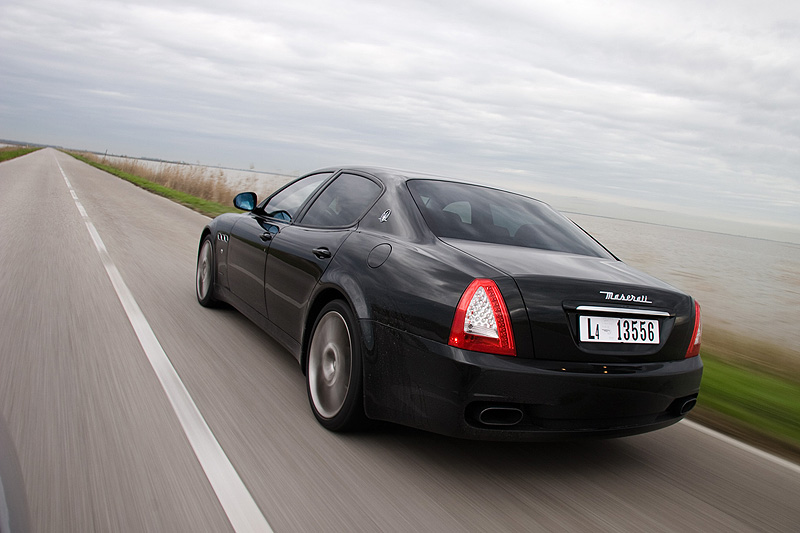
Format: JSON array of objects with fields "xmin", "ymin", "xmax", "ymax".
[{"xmin": 0, "ymin": 0, "xmax": 800, "ymax": 240}]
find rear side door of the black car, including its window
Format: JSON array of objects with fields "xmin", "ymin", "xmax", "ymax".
[{"xmin": 264, "ymin": 172, "xmax": 383, "ymax": 341}]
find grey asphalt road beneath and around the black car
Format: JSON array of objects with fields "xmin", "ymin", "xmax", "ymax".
[{"xmin": 0, "ymin": 149, "xmax": 800, "ymax": 532}]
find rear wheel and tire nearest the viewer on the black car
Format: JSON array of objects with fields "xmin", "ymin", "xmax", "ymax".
[{"xmin": 306, "ymin": 300, "xmax": 366, "ymax": 431}]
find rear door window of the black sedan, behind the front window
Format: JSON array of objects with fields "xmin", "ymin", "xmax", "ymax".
[{"xmin": 302, "ymin": 174, "xmax": 381, "ymax": 228}]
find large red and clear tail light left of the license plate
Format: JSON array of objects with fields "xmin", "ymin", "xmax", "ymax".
[{"xmin": 448, "ymin": 279, "xmax": 517, "ymax": 355}]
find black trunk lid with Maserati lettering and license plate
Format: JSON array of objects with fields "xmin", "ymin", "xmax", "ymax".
[{"xmin": 447, "ymin": 240, "xmax": 694, "ymax": 363}]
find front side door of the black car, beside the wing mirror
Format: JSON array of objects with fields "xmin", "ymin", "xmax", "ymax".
[{"xmin": 228, "ymin": 172, "xmax": 333, "ymax": 316}]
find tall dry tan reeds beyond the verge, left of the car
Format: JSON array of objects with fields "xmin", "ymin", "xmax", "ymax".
[{"xmin": 81, "ymin": 153, "xmax": 289, "ymax": 206}]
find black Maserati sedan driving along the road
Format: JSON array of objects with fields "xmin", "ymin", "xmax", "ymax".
[{"xmin": 196, "ymin": 167, "xmax": 703, "ymax": 440}]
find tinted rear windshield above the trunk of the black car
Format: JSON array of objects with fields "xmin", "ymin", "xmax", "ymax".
[{"xmin": 408, "ymin": 180, "xmax": 609, "ymax": 257}]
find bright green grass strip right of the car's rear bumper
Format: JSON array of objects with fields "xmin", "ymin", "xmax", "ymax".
[{"xmin": 698, "ymin": 350, "xmax": 800, "ymax": 450}]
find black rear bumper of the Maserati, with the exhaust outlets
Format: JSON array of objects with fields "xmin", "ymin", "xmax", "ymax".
[{"xmin": 362, "ymin": 322, "xmax": 703, "ymax": 440}]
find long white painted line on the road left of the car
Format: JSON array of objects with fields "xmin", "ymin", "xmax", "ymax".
[{"xmin": 56, "ymin": 160, "xmax": 272, "ymax": 532}]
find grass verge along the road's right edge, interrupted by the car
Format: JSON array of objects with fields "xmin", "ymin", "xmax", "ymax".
[{"xmin": 68, "ymin": 152, "xmax": 800, "ymax": 462}]
